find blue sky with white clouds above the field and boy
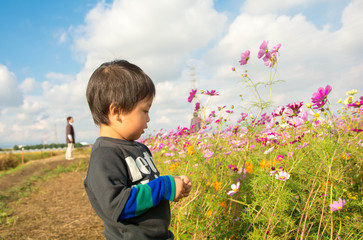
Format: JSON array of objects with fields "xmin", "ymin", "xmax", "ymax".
[{"xmin": 0, "ymin": 0, "xmax": 363, "ymax": 148}]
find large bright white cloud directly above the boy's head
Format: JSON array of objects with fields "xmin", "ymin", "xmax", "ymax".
[{"xmin": 76, "ymin": 0, "xmax": 227, "ymax": 82}]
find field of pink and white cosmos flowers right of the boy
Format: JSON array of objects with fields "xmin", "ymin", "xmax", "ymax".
[{"xmin": 140, "ymin": 42, "xmax": 363, "ymax": 239}]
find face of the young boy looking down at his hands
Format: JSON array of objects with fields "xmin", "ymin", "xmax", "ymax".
[{"xmin": 117, "ymin": 98, "xmax": 153, "ymax": 141}]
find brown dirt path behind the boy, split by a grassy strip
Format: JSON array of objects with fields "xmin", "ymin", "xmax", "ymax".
[{"xmin": 0, "ymin": 155, "xmax": 104, "ymax": 239}]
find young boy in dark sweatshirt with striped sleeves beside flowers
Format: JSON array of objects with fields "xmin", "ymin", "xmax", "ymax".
[{"xmin": 84, "ymin": 60, "xmax": 191, "ymax": 240}]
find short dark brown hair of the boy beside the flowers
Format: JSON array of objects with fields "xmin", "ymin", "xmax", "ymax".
[{"xmin": 86, "ymin": 60, "xmax": 155, "ymax": 125}]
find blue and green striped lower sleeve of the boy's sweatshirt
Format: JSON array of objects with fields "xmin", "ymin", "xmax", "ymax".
[{"xmin": 119, "ymin": 175, "xmax": 175, "ymax": 220}]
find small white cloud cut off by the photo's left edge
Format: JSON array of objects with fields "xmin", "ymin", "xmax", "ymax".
[{"xmin": 0, "ymin": 64, "xmax": 23, "ymax": 107}]
